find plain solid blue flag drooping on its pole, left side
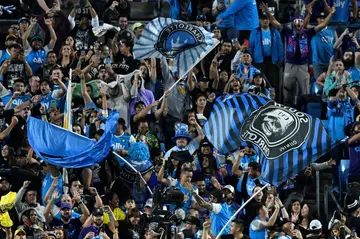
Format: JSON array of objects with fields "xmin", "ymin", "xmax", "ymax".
[{"xmin": 27, "ymin": 113, "xmax": 119, "ymax": 168}]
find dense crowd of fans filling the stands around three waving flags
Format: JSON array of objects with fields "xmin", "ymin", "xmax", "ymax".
[{"xmin": 0, "ymin": 0, "xmax": 360, "ymax": 239}]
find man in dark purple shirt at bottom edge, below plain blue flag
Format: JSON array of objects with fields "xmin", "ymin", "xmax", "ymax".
[{"xmin": 79, "ymin": 208, "xmax": 110, "ymax": 239}]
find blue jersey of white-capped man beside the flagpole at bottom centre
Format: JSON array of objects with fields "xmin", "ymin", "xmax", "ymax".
[{"xmin": 210, "ymin": 203, "xmax": 232, "ymax": 236}]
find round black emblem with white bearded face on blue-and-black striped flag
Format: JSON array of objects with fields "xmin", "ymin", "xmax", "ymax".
[{"xmin": 240, "ymin": 101, "xmax": 310, "ymax": 159}]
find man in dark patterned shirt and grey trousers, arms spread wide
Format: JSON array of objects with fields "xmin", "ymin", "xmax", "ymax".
[{"xmin": 260, "ymin": 3, "xmax": 336, "ymax": 106}]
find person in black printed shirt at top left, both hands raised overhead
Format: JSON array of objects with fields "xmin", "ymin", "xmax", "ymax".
[{"xmin": 68, "ymin": 1, "xmax": 99, "ymax": 51}]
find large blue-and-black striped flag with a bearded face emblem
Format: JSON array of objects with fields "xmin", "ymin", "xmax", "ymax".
[{"xmin": 204, "ymin": 94, "xmax": 336, "ymax": 186}]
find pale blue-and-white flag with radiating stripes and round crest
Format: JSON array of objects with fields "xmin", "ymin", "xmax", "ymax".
[{"xmin": 133, "ymin": 17, "xmax": 220, "ymax": 78}]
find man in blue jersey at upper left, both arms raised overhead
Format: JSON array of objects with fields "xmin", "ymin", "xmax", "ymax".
[{"xmin": 22, "ymin": 18, "xmax": 57, "ymax": 72}]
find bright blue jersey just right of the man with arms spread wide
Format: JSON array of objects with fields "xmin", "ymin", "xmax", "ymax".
[{"xmin": 311, "ymin": 28, "xmax": 336, "ymax": 65}]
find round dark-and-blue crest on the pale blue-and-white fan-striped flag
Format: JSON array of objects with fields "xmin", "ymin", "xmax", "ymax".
[{"xmin": 155, "ymin": 22, "xmax": 205, "ymax": 58}]
